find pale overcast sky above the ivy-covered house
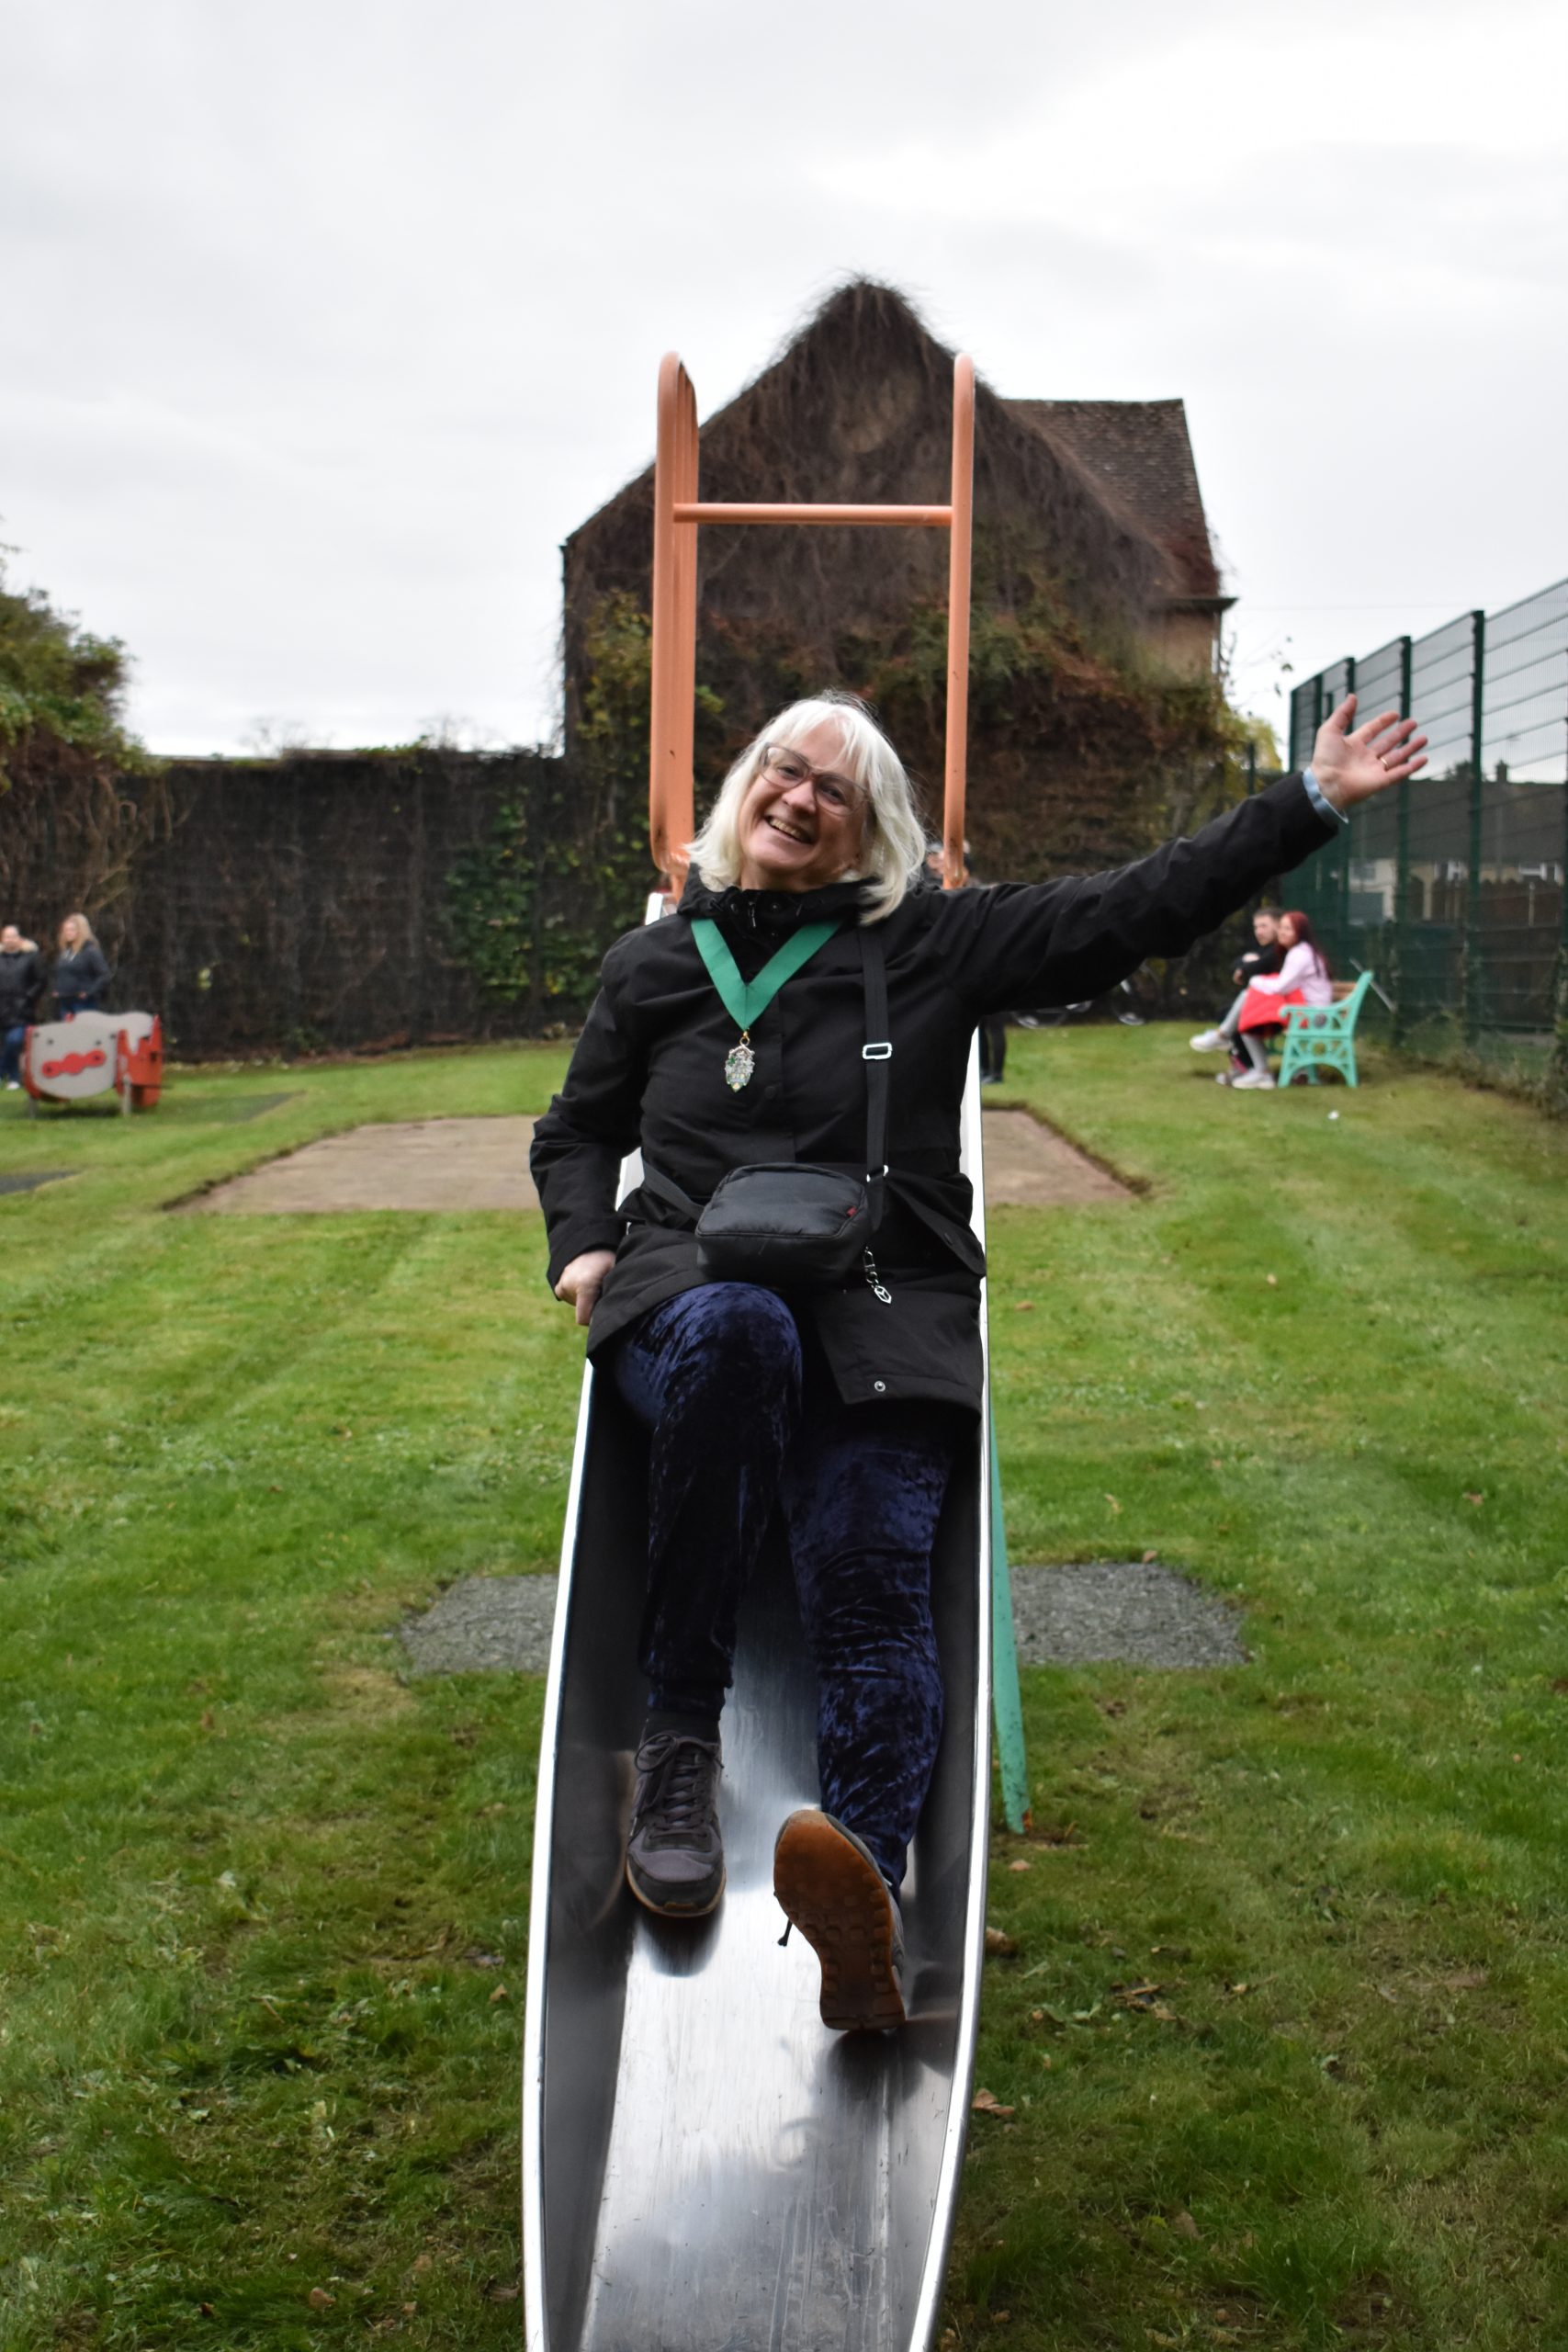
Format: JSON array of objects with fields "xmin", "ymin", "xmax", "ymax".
[{"xmin": 0, "ymin": 0, "xmax": 1568, "ymax": 751}]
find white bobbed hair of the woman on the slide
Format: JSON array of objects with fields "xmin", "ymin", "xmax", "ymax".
[{"xmin": 691, "ymin": 694, "xmax": 926, "ymax": 922}]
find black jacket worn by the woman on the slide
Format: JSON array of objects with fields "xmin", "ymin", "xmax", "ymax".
[{"xmin": 531, "ymin": 776, "xmax": 1333, "ymax": 1408}]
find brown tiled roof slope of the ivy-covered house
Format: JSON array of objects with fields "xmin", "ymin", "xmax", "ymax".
[{"xmin": 1004, "ymin": 400, "xmax": 1229, "ymax": 602}]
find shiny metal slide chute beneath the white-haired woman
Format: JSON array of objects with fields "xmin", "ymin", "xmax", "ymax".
[{"xmin": 522, "ymin": 1058, "xmax": 992, "ymax": 2352}]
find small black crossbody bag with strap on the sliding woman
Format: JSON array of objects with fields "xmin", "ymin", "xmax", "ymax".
[{"xmin": 642, "ymin": 924, "xmax": 894, "ymax": 1296}]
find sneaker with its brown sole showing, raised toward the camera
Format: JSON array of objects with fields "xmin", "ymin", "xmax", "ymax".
[{"xmin": 773, "ymin": 1804, "xmax": 908, "ymax": 2034}]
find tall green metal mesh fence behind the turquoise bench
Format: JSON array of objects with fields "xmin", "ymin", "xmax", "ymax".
[{"xmin": 1288, "ymin": 581, "xmax": 1568, "ymax": 1072}]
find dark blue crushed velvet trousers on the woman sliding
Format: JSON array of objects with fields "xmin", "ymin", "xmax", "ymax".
[{"xmin": 611, "ymin": 1282, "xmax": 966, "ymax": 1886}]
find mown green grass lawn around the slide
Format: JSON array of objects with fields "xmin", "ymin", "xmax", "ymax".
[{"xmin": 0, "ymin": 1028, "xmax": 1568, "ymax": 2352}]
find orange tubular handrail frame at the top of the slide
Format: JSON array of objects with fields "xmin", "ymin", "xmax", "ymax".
[{"xmin": 649, "ymin": 350, "xmax": 976, "ymax": 896}]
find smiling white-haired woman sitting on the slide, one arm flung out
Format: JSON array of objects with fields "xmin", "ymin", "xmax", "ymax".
[{"xmin": 531, "ymin": 694, "xmax": 1425, "ymax": 2028}]
